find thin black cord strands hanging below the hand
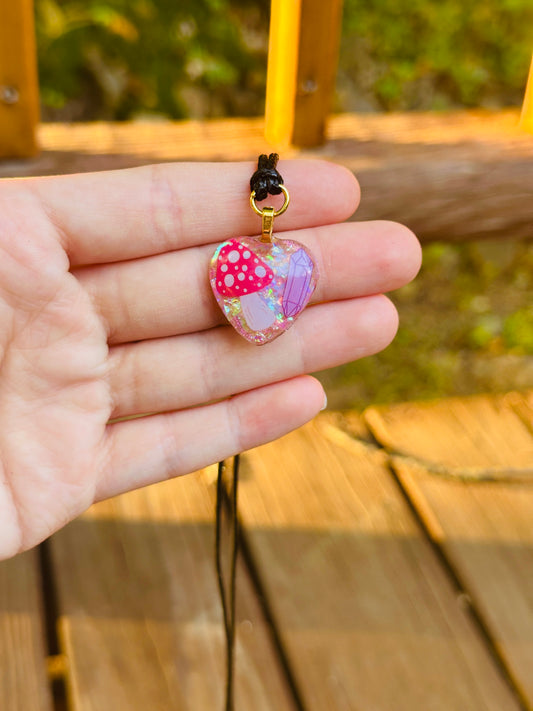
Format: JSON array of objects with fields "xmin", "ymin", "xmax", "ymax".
[{"xmin": 215, "ymin": 454, "xmax": 239, "ymax": 711}]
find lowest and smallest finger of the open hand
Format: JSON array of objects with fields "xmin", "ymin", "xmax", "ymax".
[{"xmin": 96, "ymin": 376, "xmax": 324, "ymax": 500}]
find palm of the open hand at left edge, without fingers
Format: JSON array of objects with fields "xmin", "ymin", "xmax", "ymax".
[{"xmin": 0, "ymin": 197, "xmax": 111, "ymax": 552}]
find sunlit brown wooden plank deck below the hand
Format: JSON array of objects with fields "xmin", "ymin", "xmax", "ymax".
[{"xmin": 0, "ymin": 393, "xmax": 533, "ymax": 711}]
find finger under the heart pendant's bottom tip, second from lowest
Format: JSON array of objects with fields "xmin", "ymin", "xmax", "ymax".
[{"xmin": 110, "ymin": 296, "xmax": 398, "ymax": 417}]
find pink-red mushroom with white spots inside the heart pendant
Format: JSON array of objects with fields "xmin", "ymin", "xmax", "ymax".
[{"xmin": 215, "ymin": 239, "xmax": 276, "ymax": 331}]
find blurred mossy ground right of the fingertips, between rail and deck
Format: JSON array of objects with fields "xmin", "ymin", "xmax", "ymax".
[{"xmin": 318, "ymin": 239, "xmax": 533, "ymax": 409}]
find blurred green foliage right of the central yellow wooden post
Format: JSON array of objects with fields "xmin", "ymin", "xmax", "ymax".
[{"xmin": 340, "ymin": 0, "xmax": 533, "ymax": 110}]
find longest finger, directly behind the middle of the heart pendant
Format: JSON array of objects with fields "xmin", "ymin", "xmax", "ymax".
[{"xmin": 76, "ymin": 222, "xmax": 420, "ymax": 343}]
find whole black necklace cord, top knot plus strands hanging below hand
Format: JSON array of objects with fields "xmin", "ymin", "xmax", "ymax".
[{"xmin": 215, "ymin": 153, "xmax": 283, "ymax": 711}]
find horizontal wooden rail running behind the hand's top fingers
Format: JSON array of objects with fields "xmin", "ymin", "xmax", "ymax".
[{"xmin": 0, "ymin": 111, "xmax": 533, "ymax": 241}]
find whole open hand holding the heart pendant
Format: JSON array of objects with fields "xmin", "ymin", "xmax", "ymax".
[{"xmin": 0, "ymin": 161, "xmax": 420, "ymax": 558}]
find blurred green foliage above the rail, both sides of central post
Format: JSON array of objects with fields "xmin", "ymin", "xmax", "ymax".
[{"xmin": 36, "ymin": 0, "xmax": 533, "ymax": 120}]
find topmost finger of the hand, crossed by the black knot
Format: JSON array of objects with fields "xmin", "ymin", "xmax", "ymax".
[{"xmin": 27, "ymin": 160, "xmax": 359, "ymax": 265}]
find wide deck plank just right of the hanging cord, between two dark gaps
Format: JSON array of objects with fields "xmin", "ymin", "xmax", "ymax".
[{"xmin": 234, "ymin": 418, "xmax": 520, "ymax": 711}]
